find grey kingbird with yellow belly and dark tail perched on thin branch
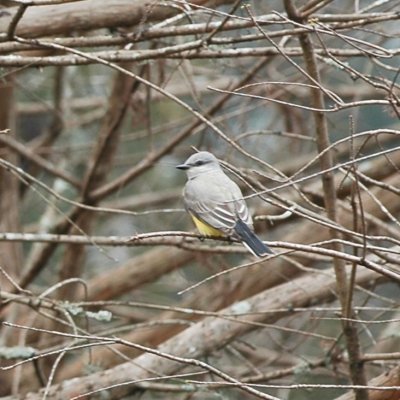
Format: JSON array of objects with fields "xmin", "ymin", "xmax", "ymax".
[{"xmin": 176, "ymin": 151, "xmax": 273, "ymax": 257}]
